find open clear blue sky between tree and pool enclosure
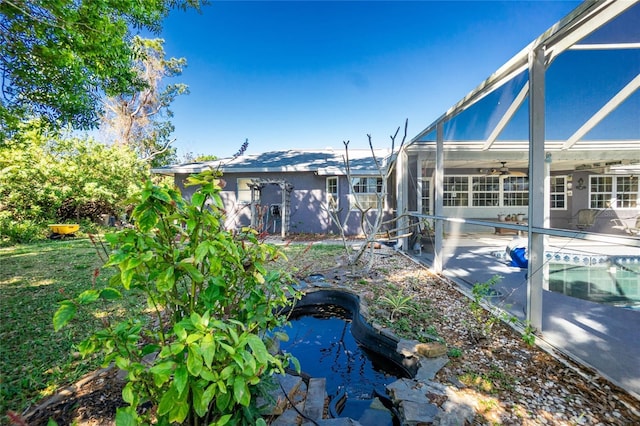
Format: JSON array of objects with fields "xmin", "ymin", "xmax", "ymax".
[{"xmin": 160, "ymin": 1, "xmax": 580, "ymax": 157}]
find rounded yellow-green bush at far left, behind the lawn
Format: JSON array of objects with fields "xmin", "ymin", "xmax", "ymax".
[{"xmin": 0, "ymin": 123, "xmax": 148, "ymax": 241}]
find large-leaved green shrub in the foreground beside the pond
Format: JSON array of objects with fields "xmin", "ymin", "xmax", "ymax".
[{"xmin": 54, "ymin": 171, "xmax": 296, "ymax": 425}]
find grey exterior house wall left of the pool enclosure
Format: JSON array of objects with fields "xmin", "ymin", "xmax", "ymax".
[{"xmin": 175, "ymin": 172, "xmax": 394, "ymax": 235}]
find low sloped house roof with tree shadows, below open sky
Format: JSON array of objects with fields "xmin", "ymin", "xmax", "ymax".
[{"xmin": 151, "ymin": 149, "xmax": 390, "ymax": 176}]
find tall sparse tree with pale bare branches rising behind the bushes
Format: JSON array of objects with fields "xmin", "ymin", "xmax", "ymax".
[{"xmin": 102, "ymin": 37, "xmax": 189, "ymax": 166}]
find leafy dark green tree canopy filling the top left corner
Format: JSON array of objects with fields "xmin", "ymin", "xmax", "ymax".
[{"xmin": 0, "ymin": 0, "xmax": 208, "ymax": 142}]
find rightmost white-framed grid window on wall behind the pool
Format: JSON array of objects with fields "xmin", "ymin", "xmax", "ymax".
[{"xmin": 589, "ymin": 176, "xmax": 640, "ymax": 209}]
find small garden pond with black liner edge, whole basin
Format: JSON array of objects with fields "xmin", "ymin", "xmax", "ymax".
[{"xmin": 280, "ymin": 291, "xmax": 411, "ymax": 425}]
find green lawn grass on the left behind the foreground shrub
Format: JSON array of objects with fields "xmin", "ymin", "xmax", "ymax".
[{"xmin": 0, "ymin": 239, "xmax": 145, "ymax": 415}]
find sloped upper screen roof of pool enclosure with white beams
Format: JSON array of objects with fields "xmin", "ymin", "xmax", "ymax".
[{"xmin": 406, "ymin": 0, "xmax": 640, "ymax": 171}]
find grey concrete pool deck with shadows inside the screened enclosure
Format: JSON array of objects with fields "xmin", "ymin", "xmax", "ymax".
[{"xmin": 409, "ymin": 234, "xmax": 640, "ymax": 399}]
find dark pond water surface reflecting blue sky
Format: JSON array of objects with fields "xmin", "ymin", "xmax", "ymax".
[{"xmin": 280, "ymin": 306, "xmax": 406, "ymax": 424}]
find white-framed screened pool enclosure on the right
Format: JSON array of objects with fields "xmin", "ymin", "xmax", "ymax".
[{"xmin": 396, "ymin": 1, "xmax": 640, "ymax": 395}]
